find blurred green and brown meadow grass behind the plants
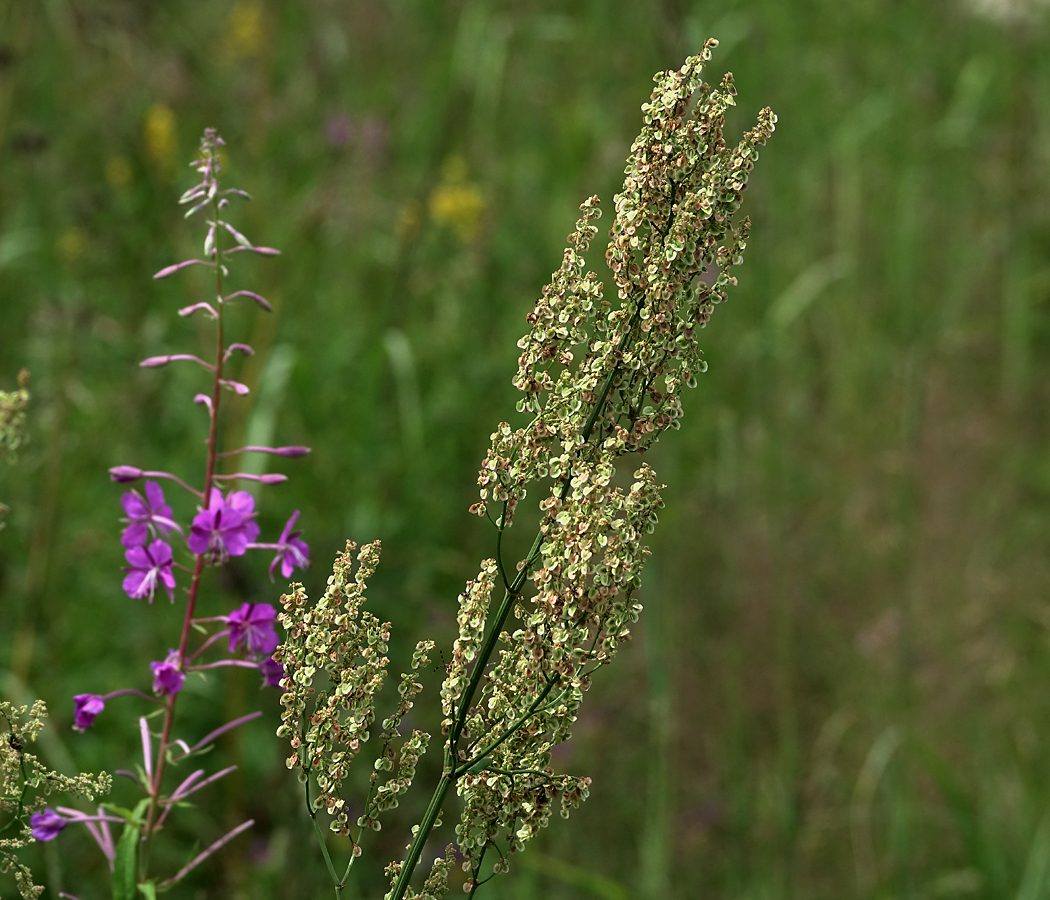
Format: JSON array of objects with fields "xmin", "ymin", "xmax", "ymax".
[{"xmin": 0, "ymin": 0, "xmax": 1050, "ymax": 900}]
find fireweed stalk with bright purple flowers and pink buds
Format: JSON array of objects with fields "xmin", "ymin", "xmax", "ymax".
[{"xmin": 32, "ymin": 129, "xmax": 310, "ymax": 900}]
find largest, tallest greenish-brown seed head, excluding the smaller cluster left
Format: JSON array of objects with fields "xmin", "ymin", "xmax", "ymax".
[{"xmin": 443, "ymin": 41, "xmax": 776, "ymax": 877}]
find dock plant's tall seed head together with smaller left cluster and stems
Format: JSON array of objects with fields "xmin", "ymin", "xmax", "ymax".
[{"xmin": 274, "ymin": 40, "xmax": 776, "ymax": 900}]
